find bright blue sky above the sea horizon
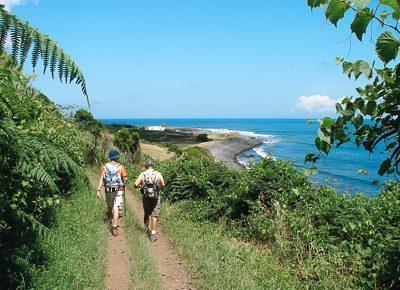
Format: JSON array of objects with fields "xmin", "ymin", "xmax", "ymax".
[{"xmin": 0, "ymin": 0, "xmax": 373, "ymax": 118}]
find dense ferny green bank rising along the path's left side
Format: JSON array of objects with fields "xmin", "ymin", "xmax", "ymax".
[{"xmin": 0, "ymin": 57, "xmax": 90, "ymax": 288}]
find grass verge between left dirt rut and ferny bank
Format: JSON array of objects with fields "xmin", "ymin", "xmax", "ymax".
[{"xmin": 32, "ymin": 180, "xmax": 107, "ymax": 289}]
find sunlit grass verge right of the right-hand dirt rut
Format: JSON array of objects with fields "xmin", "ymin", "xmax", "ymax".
[{"xmin": 161, "ymin": 204, "xmax": 301, "ymax": 289}]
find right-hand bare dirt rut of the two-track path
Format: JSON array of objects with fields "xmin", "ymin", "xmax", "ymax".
[{"xmin": 126, "ymin": 190, "xmax": 194, "ymax": 290}]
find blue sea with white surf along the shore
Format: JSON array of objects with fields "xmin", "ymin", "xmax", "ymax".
[{"xmin": 102, "ymin": 119, "xmax": 388, "ymax": 196}]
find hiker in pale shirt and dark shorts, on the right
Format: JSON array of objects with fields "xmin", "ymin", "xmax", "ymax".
[{"xmin": 135, "ymin": 160, "xmax": 165, "ymax": 242}]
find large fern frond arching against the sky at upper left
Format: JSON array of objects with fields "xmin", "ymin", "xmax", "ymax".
[{"xmin": 0, "ymin": 5, "xmax": 90, "ymax": 108}]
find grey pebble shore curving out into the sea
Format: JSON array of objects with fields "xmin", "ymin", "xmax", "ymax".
[{"xmin": 174, "ymin": 128, "xmax": 263, "ymax": 170}]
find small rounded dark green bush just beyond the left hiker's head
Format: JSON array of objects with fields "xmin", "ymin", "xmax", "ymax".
[{"xmin": 114, "ymin": 128, "xmax": 140, "ymax": 163}]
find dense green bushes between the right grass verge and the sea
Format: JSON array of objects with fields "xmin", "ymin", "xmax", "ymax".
[{"xmin": 160, "ymin": 154, "xmax": 400, "ymax": 288}]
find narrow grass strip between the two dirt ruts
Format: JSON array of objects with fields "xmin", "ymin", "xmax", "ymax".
[{"xmin": 125, "ymin": 195, "xmax": 161, "ymax": 290}]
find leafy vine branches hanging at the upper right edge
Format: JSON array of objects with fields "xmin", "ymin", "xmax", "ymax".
[{"xmin": 306, "ymin": 0, "xmax": 400, "ymax": 175}]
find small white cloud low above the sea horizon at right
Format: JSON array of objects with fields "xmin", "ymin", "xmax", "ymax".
[{"xmin": 296, "ymin": 95, "xmax": 342, "ymax": 114}]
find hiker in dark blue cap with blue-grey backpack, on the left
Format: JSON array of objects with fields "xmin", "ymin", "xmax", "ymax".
[{"xmin": 96, "ymin": 150, "xmax": 128, "ymax": 236}]
